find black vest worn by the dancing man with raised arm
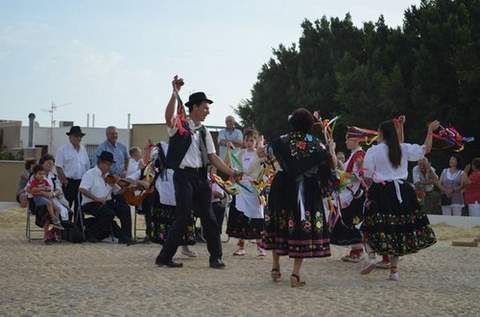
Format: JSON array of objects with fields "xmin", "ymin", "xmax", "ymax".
[{"xmin": 167, "ymin": 129, "xmax": 208, "ymax": 170}]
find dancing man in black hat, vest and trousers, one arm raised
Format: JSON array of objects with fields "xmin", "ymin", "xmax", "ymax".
[{"xmin": 155, "ymin": 76, "xmax": 238, "ymax": 268}]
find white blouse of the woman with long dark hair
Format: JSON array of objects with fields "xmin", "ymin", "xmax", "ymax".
[{"xmin": 363, "ymin": 143, "xmax": 425, "ymax": 183}]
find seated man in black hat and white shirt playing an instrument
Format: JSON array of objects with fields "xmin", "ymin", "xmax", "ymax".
[{"xmin": 79, "ymin": 151, "xmax": 132, "ymax": 245}]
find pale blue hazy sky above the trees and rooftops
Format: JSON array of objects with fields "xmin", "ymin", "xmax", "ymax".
[{"xmin": 0, "ymin": 0, "xmax": 420, "ymax": 128}]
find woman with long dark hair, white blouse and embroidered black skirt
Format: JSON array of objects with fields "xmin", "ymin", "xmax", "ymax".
[{"xmin": 361, "ymin": 120, "xmax": 439, "ymax": 281}]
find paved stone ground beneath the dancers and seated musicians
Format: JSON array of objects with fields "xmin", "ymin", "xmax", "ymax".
[{"xmin": 0, "ymin": 206, "xmax": 480, "ymax": 317}]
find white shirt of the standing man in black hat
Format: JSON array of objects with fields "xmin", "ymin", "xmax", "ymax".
[{"xmin": 55, "ymin": 141, "xmax": 90, "ymax": 179}]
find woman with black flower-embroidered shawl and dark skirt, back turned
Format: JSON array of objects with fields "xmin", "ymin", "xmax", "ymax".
[{"xmin": 264, "ymin": 108, "xmax": 334, "ymax": 287}]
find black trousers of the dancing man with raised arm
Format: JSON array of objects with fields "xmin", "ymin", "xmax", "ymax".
[{"xmin": 158, "ymin": 169, "xmax": 222, "ymax": 261}]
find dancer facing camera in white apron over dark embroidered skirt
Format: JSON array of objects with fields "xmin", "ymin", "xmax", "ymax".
[{"xmin": 227, "ymin": 129, "xmax": 266, "ymax": 256}]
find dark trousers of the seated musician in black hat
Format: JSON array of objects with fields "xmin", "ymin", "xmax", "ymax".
[{"xmin": 82, "ymin": 200, "xmax": 131, "ymax": 242}]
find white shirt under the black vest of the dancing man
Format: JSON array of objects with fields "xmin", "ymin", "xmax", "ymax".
[{"xmin": 167, "ymin": 120, "xmax": 216, "ymax": 168}]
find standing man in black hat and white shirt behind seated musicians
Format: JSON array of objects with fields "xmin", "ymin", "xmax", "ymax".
[{"xmin": 55, "ymin": 126, "xmax": 90, "ymax": 211}]
